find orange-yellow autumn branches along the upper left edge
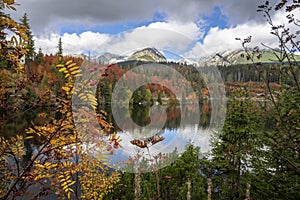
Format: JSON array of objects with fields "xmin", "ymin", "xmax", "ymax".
[{"xmin": 0, "ymin": 0, "xmax": 29, "ymax": 115}]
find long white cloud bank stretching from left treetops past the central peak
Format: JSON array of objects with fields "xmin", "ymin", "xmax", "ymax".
[{"xmin": 34, "ymin": 21, "xmax": 203, "ymax": 55}]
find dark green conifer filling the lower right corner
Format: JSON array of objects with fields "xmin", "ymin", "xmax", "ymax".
[{"xmin": 251, "ymin": 86, "xmax": 300, "ymax": 200}]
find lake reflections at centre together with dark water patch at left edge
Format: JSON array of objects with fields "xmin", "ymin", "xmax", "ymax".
[{"xmin": 0, "ymin": 102, "xmax": 220, "ymax": 172}]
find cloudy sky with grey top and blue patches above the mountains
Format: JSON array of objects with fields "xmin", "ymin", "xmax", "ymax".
[{"xmin": 11, "ymin": 0, "xmax": 296, "ymax": 58}]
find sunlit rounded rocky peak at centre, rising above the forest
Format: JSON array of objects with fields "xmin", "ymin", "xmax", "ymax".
[{"xmin": 128, "ymin": 48, "xmax": 167, "ymax": 62}]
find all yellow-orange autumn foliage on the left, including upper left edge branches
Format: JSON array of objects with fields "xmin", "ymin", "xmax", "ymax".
[{"xmin": 0, "ymin": 0, "xmax": 120, "ymax": 199}]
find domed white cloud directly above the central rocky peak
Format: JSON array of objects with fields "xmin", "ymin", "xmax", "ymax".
[{"xmin": 108, "ymin": 21, "xmax": 203, "ymax": 54}]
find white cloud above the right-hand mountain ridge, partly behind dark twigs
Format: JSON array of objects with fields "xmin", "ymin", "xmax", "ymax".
[{"xmin": 184, "ymin": 11, "xmax": 300, "ymax": 58}]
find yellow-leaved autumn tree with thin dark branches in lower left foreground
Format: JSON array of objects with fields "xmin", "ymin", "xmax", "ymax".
[{"xmin": 0, "ymin": 61, "xmax": 120, "ymax": 199}]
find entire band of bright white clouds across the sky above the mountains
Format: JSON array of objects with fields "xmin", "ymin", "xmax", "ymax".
[{"xmin": 35, "ymin": 8, "xmax": 298, "ymax": 59}]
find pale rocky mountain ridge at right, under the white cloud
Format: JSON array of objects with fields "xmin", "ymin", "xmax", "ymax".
[{"xmin": 199, "ymin": 50, "xmax": 300, "ymax": 66}]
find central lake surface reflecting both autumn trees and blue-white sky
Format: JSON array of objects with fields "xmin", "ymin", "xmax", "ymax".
[{"xmin": 101, "ymin": 102, "xmax": 218, "ymax": 172}]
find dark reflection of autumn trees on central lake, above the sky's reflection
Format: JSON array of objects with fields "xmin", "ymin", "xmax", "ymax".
[{"xmin": 103, "ymin": 101, "xmax": 212, "ymax": 132}]
